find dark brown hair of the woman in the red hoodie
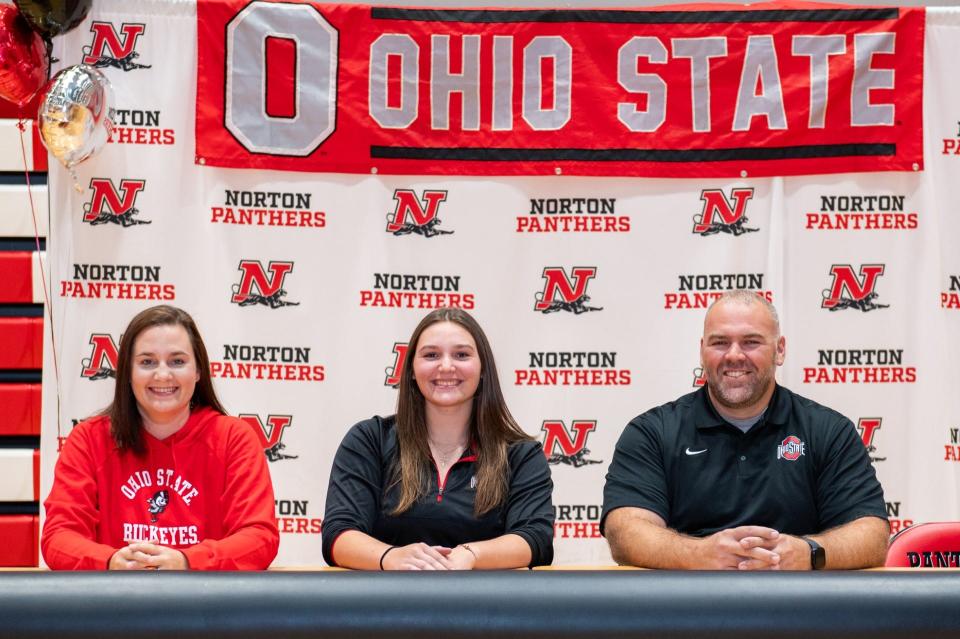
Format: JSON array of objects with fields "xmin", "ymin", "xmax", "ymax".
[{"xmin": 102, "ymin": 305, "xmax": 227, "ymax": 455}]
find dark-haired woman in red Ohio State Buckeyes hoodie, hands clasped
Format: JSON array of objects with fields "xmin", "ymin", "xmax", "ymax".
[{"xmin": 40, "ymin": 306, "xmax": 279, "ymax": 570}]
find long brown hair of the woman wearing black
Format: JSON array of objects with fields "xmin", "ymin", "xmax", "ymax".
[{"xmin": 393, "ymin": 308, "xmax": 532, "ymax": 516}]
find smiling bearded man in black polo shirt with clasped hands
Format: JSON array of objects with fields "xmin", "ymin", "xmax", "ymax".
[{"xmin": 600, "ymin": 291, "xmax": 889, "ymax": 570}]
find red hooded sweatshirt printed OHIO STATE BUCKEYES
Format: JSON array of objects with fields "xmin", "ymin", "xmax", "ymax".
[{"xmin": 40, "ymin": 408, "xmax": 280, "ymax": 570}]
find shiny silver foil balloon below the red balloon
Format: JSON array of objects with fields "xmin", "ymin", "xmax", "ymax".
[{"xmin": 37, "ymin": 64, "xmax": 114, "ymax": 169}]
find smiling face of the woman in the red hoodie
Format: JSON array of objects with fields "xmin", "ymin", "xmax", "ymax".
[{"xmin": 130, "ymin": 324, "xmax": 200, "ymax": 430}]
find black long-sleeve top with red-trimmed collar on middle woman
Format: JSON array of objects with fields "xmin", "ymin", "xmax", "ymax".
[{"xmin": 323, "ymin": 416, "xmax": 554, "ymax": 566}]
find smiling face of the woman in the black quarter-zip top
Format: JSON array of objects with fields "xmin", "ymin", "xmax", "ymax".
[{"xmin": 413, "ymin": 322, "xmax": 480, "ymax": 416}]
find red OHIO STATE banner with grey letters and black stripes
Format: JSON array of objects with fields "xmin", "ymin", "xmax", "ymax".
[{"xmin": 197, "ymin": 0, "xmax": 923, "ymax": 177}]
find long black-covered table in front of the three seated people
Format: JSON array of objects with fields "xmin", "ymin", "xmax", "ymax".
[{"xmin": 0, "ymin": 570, "xmax": 960, "ymax": 639}]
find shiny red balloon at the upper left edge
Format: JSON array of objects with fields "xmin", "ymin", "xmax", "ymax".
[{"xmin": 0, "ymin": 4, "xmax": 50, "ymax": 107}]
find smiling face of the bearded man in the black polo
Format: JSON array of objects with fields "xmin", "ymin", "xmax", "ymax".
[{"xmin": 700, "ymin": 300, "xmax": 786, "ymax": 419}]
